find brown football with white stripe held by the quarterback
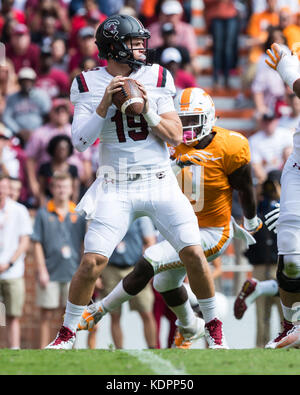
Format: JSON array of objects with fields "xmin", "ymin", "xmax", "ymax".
[{"xmin": 113, "ymin": 78, "xmax": 144, "ymax": 116}]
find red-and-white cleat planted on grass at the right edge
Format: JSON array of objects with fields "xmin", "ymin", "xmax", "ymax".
[{"xmin": 265, "ymin": 320, "xmax": 300, "ymax": 349}]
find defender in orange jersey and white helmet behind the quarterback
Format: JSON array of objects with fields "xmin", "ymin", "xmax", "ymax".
[{"xmin": 80, "ymin": 88, "xmax": 262, "ymax": 349}]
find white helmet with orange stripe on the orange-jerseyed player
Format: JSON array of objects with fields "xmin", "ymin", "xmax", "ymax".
[{"xmin": 174, "ymin": 88, "xmax": 216, "ymax": 144}]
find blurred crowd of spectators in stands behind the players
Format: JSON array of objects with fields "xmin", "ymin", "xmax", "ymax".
[{"xmin": 0, "ymin": 0, "xmax": 300, "ymax": 348}]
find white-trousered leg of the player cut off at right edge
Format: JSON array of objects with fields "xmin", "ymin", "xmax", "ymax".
[{"xmin": 266, "ymin": 157, "xmax": 300, "ymax": 348}]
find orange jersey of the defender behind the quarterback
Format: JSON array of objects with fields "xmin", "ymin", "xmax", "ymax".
[{"xmin": 170, "ymin": 126, "xmax": 250, "ymax": 227}]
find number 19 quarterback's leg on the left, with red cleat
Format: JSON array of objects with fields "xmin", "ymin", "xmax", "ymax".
[{"xmin": 47, "ymin": 196, "xmax": 132, "ymax": 349}]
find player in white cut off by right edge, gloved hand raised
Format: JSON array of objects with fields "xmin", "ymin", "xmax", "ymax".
[{"xmin": 258, "ymin": 43, "xmax": 300, "ymax": 349}]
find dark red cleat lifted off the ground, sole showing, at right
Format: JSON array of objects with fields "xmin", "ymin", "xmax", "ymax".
[{"xmin": 234, "ymin": 278, "xmax": 259, "ymax": 320}]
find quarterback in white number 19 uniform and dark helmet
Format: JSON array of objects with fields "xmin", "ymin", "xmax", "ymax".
[{"xmin": 47, "ymin": 15, "xmax": 216, "ymax": 349}]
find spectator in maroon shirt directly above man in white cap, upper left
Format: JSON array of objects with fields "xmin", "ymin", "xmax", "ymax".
[{"xmin": 6, "ymin": 24, "xmax": 40, "ymax": 73}]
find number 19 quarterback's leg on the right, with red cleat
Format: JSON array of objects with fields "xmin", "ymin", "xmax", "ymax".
[{"xmin": 153, "ymin": 184, "xmax": 227, "ymax": 348}]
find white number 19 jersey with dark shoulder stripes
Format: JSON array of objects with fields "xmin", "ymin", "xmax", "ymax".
[{"xmin": 71, "ymin": 64, "xmax": 176, "ymax": 174}]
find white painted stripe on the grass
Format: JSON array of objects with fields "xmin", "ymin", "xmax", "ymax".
[{"xmin": 122, "ymin": 350, "xmax": 187, "ymax": 375}]
